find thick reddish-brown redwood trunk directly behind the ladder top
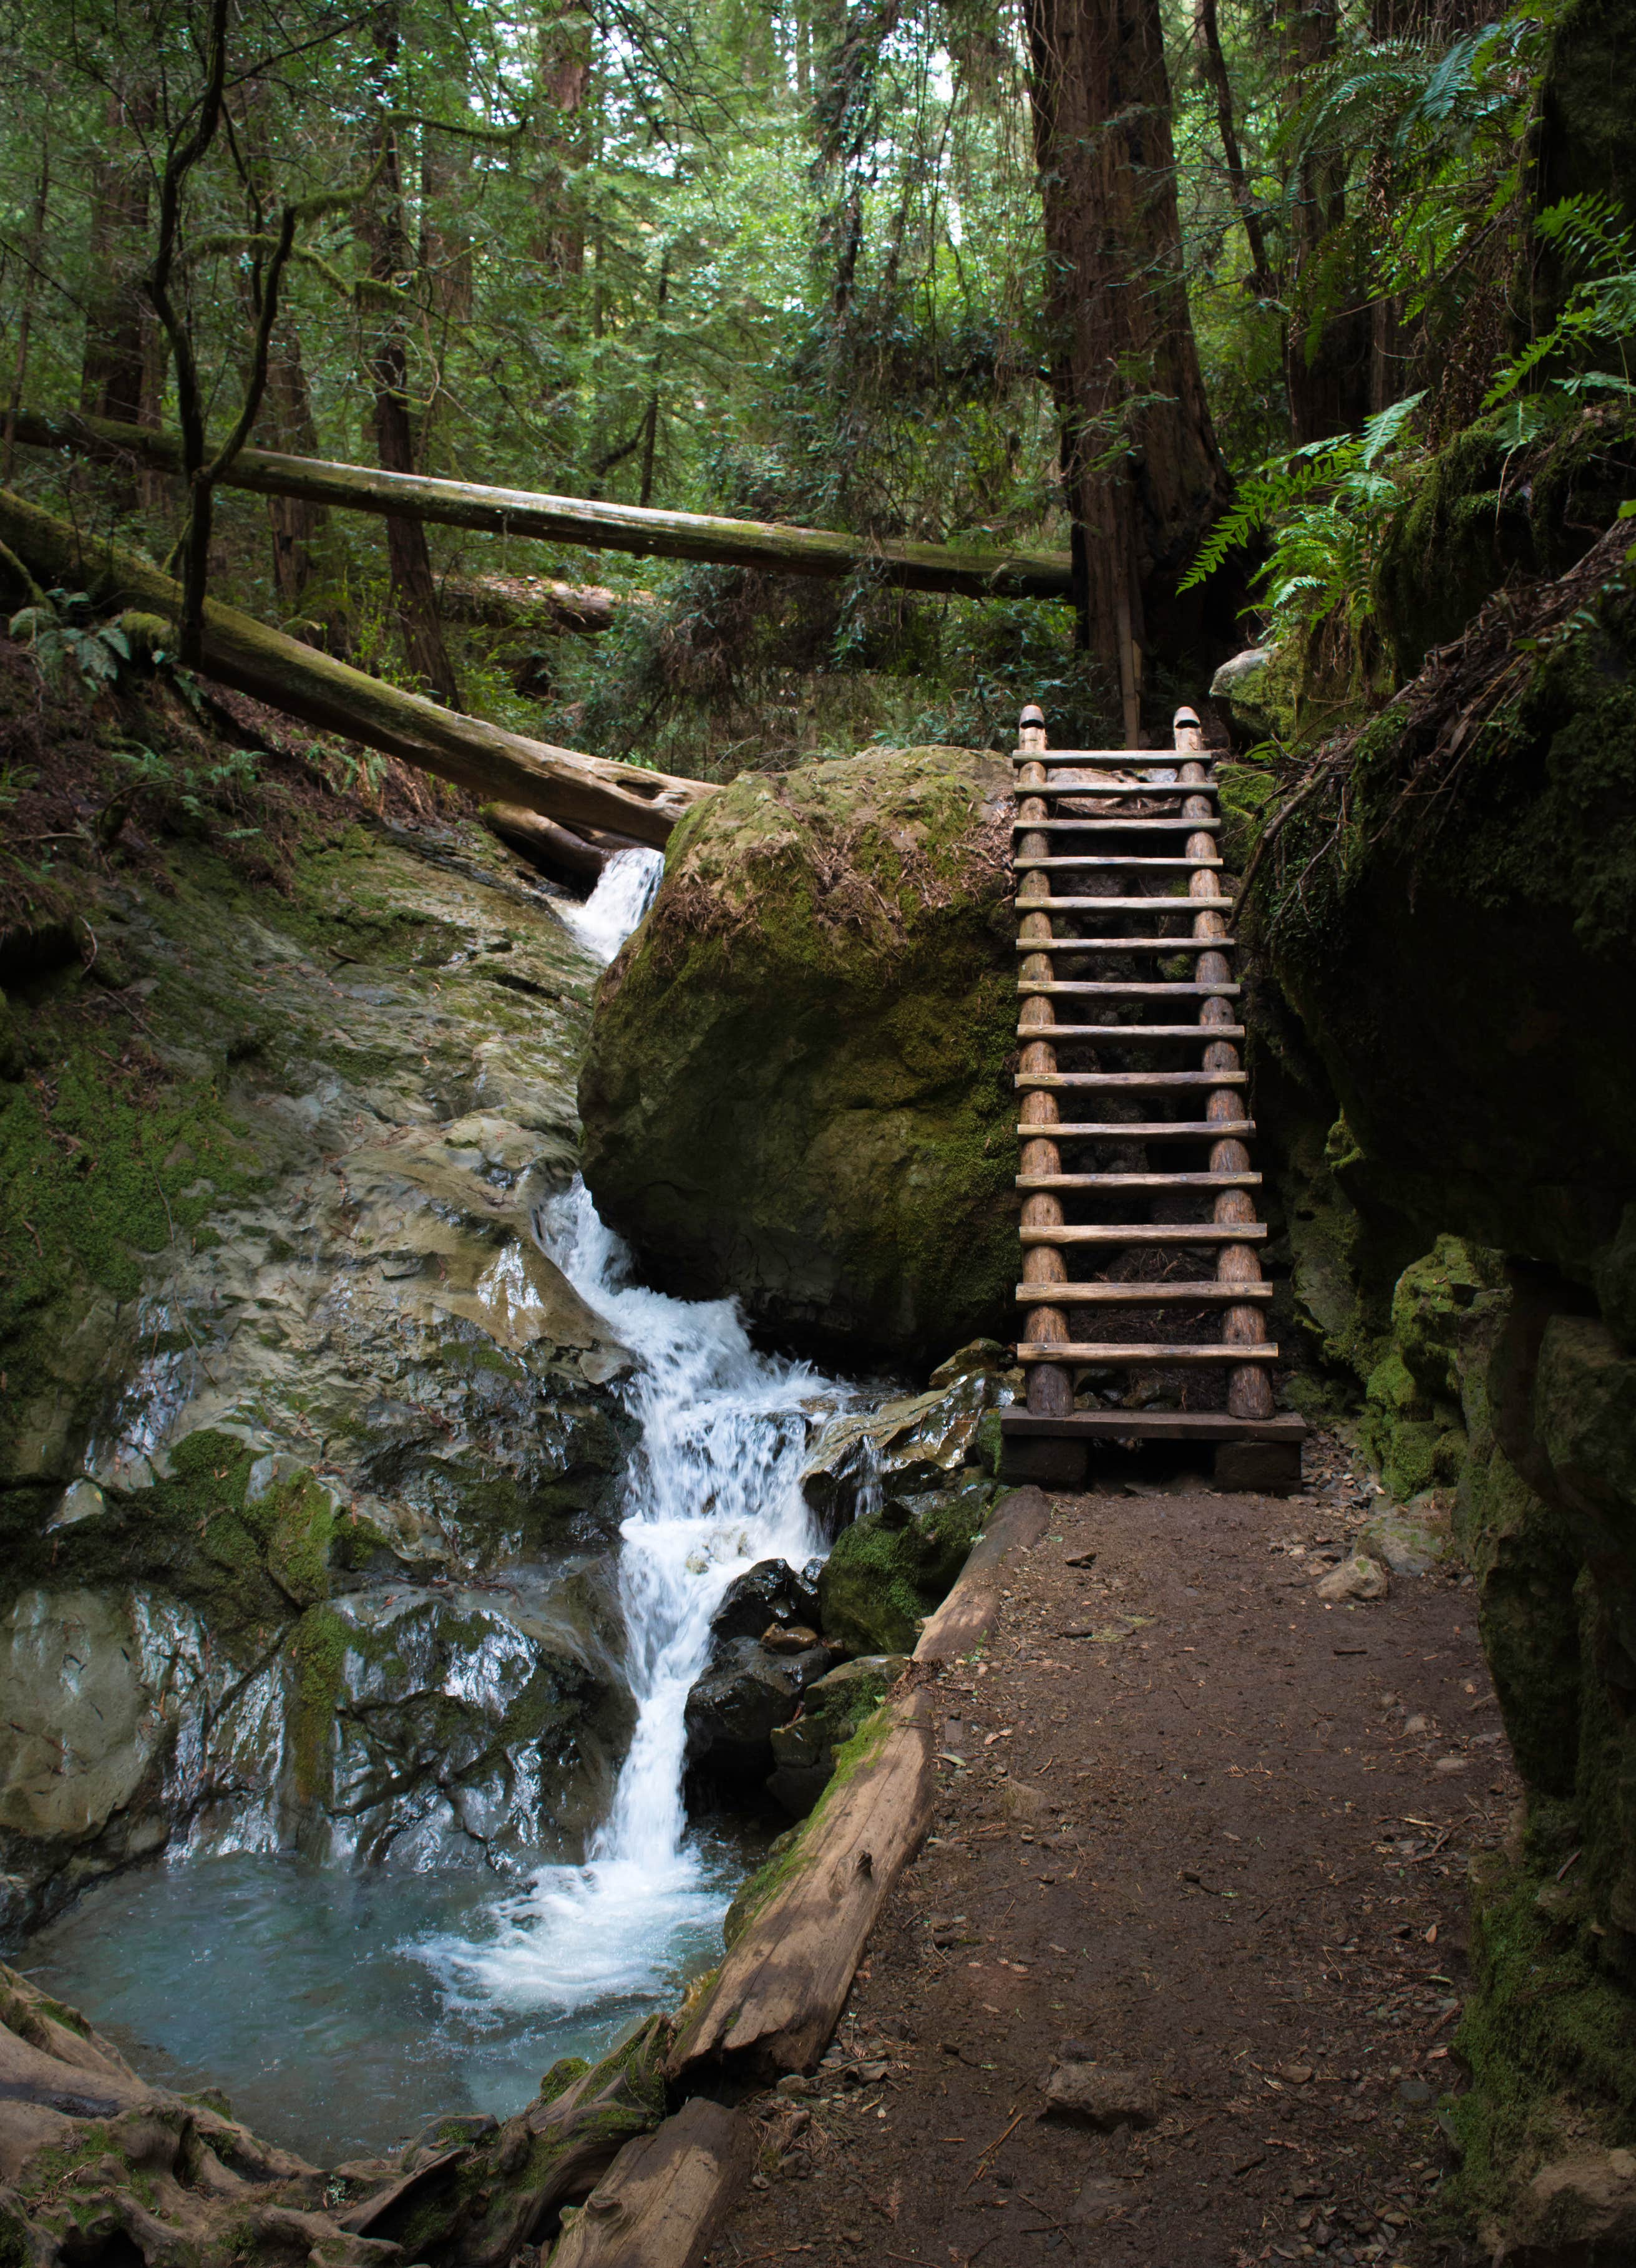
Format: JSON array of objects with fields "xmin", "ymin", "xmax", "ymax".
[{"xmin": 1023, "ymin": 0, "xmax": 1230, "ymax": 726}]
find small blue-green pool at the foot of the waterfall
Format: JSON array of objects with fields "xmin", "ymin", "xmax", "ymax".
[{"xmin": 11, "ymin": 1844, "xmax": 753, "ymax": 2166}]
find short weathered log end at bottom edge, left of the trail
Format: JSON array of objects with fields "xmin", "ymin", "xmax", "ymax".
[{"xmin": 552, "ymin": 2096, "xmax": 756, "ymax": 2268}]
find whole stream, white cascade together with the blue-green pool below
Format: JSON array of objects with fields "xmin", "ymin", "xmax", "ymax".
[{"xmin": 22, "ymin": 853, "xmax": 858, "ymax": 2164}]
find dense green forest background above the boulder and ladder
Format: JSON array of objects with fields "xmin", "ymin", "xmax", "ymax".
[{"xmin": 0, "ymin": 0, "xmax": 1636, "ymax": 778}]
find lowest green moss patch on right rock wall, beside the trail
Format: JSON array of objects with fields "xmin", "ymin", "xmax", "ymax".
[{"xmin": 1448, "ymin": 1853, "xmax": 1636, "ymax": 2225}]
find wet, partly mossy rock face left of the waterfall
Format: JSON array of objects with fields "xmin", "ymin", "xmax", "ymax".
[{"xmin": 0, "ymin": 830, "xmax": 633, "ymax": 1925}]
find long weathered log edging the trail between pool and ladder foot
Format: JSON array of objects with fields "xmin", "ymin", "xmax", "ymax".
[{"xmin": 665, "ymin": 1488, "xmax": 1048, "ymax": 2086}]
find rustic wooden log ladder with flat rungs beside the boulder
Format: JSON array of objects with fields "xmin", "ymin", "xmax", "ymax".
[{"xmin": 1001, "ymin": 708, "xmax": 1307, "ymax": 1490}]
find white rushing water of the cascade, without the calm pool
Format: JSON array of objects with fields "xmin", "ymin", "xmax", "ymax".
[{"xmin": 413, "ymin": 850, "xmax": 853, "ymax": 2012}]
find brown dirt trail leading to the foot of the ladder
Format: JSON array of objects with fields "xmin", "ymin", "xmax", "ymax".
[{"xmin": 710, "ymin": 1451, "xmax": 1518, "ymax": 2268}]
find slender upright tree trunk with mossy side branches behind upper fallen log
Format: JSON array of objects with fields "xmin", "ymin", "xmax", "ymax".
[{"xmin": 370, "ymin": 0, "xmax": 460, "ymax": 708}]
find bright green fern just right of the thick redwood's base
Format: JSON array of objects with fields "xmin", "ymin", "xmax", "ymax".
[{"xmin": 1180, "ymin": 394, "xmax": 1425, "ymax": 651}]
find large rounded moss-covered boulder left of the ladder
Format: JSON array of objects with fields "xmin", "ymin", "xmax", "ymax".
[{"xmin": 578, "ymin": 749, "xmax": 1016, "ymax": 1358}]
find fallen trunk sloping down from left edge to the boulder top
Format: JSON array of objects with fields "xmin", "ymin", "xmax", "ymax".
[{"xmin": 0, "ymin": 490, "xmax": 717, "ymax": 848}]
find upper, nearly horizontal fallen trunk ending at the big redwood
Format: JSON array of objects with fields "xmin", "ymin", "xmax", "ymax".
[{"xmin": 16, "ymin": 411, "xmax": 1073, "ymax": 599}]
